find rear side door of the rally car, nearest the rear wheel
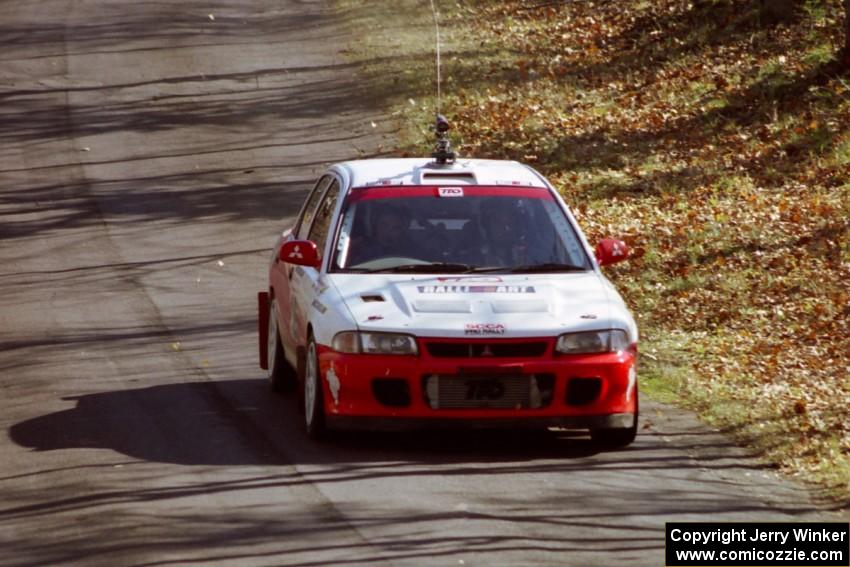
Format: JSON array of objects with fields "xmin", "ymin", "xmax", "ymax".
[{"xmin": 271, "ymin": 175, "xmax": 334, "ymax": 358}]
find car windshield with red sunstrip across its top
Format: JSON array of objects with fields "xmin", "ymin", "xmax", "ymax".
[{"xmin": 332, "ymin": 186, "xmax": 590, "ymax": 273}]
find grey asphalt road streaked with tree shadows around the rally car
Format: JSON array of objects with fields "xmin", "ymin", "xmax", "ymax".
[{"xmin": 0, "ymin": 0, "xmax": 847, "ymax": 566}]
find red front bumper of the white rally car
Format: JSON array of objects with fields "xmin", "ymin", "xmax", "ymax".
[{"xmin": 319, "ymin": 338, "xmax": 637, "ymax": 428}]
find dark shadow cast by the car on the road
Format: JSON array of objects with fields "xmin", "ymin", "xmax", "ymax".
[{"xmin": 9, "ymin": 380, "xmax": 597, "ymax": 472}]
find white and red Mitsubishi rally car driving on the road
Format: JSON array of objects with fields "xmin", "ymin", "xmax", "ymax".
[{"xmin": 259, "ymin": 159, "xmax": 638, "ymax": 447}]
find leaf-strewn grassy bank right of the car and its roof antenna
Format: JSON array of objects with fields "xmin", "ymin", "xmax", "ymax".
[{"xmin": 408, "ymin": 0, "xmax": 850, "ymax": 487}]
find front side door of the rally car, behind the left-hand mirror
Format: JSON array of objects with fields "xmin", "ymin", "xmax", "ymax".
[{"xmin": 290, "ymin": 178, "xmax": 340, "ymax": 345}]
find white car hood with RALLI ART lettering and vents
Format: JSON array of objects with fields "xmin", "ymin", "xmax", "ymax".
[{"xmin": 330, "ymin": 271, "xmax": 637, "ymax": 341}]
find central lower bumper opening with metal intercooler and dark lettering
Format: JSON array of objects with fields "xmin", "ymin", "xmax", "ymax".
[{"xmin": 422, "ymin": 374, "xmax": 555, "ymax": 410}]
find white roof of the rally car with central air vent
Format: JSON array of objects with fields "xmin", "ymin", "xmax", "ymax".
[{"xmin": 331, "ymin": 158, "xmax": 549, "ymax": 191}]
